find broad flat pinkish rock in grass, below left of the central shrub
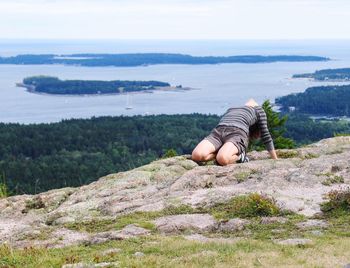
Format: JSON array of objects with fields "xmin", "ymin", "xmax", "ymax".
[{"xmin": 154, "ymin": 214, "xmax": 218, "ymax": 233}]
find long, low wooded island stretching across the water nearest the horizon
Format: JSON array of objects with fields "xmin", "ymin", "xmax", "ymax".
[{"xmin": 0, "ymin": 53, "xmax": 330, "ymax": 67}]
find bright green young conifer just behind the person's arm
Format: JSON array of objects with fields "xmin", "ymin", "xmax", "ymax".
[{"xmin": 249, "ymin": 100, "xmax": 295, "ymax": 150}]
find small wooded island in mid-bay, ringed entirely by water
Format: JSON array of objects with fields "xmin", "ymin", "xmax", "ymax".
[{"xmin": 16, "ymin": 76, "xmax": 175, "ymax": 95}]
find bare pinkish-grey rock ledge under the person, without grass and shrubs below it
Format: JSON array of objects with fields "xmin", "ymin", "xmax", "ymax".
[{"xmin": 0, "ymin": 137, "xmax": 350, "ymax": 247}]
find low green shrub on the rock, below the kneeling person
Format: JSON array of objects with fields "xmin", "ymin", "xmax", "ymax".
[{"xmin": 211, "ymin": 193, "xmax": 281, "ymax": 219}]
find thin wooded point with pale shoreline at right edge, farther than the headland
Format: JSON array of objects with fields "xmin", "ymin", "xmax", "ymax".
[{"xmin": 293, "ymin": 68, "xmax": 350, "ymax": 82}]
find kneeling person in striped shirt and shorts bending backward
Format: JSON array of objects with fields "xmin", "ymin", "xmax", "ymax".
[{"xmin": 192, "ymin": 99, "xmax": 277, "ymax": 166}]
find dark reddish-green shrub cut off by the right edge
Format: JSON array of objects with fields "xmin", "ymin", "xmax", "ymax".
[{"xmin": 321, "ymin": 188, "xmax": 350, "ymax": 212}]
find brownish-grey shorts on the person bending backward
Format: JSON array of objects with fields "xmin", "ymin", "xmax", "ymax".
[{"xmin": 204, "ymin": 126, "xmax": 248, "ymax": 154}]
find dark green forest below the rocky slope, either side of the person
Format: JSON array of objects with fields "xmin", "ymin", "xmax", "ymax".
[{"xmin": 0, "ymin": 111, "xmax": 350, "ymax": 194}]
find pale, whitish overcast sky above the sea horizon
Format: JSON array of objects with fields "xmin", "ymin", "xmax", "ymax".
[{"xmin": 0, "ymin": 0, "xmax": 350, "ymax": 40}]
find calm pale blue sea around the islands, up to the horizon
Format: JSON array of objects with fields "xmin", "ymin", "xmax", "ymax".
[{"xmin": 0, "ymin": 39, "xmax": 350, "ymax": 124}]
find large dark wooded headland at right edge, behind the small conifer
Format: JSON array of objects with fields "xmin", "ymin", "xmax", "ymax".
[{"xmin": 275, "ymin": 85, "xmax": 350, "ymax": 117}]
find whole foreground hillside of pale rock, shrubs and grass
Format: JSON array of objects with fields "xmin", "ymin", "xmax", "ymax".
[{"xmin": 0, "ymin": 136, "xmax": 350, "ymax": 267}]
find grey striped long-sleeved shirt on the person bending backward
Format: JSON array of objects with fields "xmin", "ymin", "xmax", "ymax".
[{"xmin": 218, "ymin": 106, "xmax": 275, "ymax": 151}]
